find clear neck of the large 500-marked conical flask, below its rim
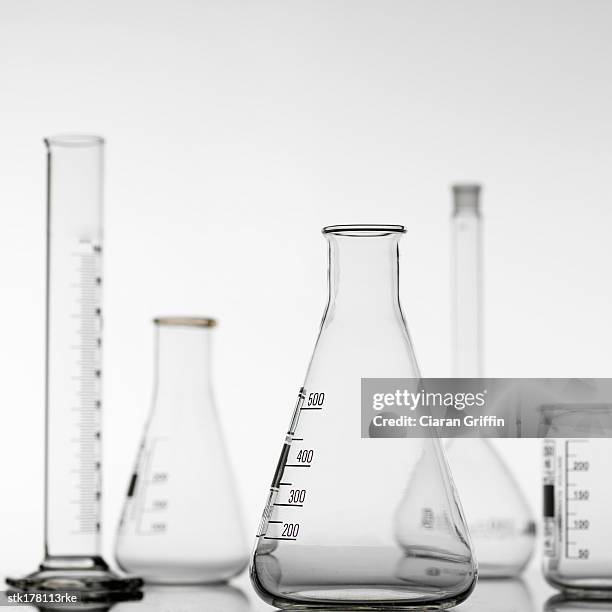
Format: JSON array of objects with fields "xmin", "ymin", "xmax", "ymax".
[{"xmin": 326, "ymin": 233, "xmax": 401, "ymax": 320}]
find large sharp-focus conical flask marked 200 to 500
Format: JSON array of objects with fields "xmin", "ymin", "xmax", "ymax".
[{"xmin": 251, "ymin": 225, "xmax": 476, "ymax": 609}]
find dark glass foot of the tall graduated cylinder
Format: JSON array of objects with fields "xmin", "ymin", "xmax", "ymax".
[{"xmin": 6, "ymin": 557, "xmax": 143, "ymax": 603}]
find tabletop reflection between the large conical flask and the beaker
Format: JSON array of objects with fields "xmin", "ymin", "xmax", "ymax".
[{"xmin": 457, "ymin": 578, "xmax": 535, "ymax": 612}]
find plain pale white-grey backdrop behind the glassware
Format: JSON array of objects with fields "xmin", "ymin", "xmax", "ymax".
[{"xmin": 0, "ymin": 0, "xmax": 612, "ymax": 572}]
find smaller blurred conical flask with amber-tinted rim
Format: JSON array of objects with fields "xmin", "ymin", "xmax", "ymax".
[{"xmin": 115, "ymin": 317, "xmax": 248, "ymax": 584}]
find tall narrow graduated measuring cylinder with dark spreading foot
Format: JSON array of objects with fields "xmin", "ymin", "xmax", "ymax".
[{"xmin": 7, "ymin": 136, "xmax": 142, "ymax": 600}]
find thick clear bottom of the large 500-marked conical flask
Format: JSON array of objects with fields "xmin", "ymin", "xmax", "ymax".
[{"xmin": 250, "ymin": 546, "xmax": 476, "ymax": 611}]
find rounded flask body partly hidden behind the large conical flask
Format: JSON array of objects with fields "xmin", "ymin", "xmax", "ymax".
[{"xmin": 446, "ymin": 438, "xmax": 536, "ymax": 578}]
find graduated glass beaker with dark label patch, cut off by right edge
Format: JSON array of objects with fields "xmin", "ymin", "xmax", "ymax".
[{"xmin": 541, "ymin": 404, "xmax": 612, "ymax": 598}]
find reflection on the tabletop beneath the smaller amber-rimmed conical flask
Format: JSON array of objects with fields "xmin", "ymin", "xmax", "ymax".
[{"xmin": 113, "ymin": 584, "xmax": 249, "ymax": 612}]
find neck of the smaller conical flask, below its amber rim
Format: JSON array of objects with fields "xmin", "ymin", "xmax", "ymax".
[{"xmin": 155, "ymin": 325, "xmax": 212, "ymax": 396}]
